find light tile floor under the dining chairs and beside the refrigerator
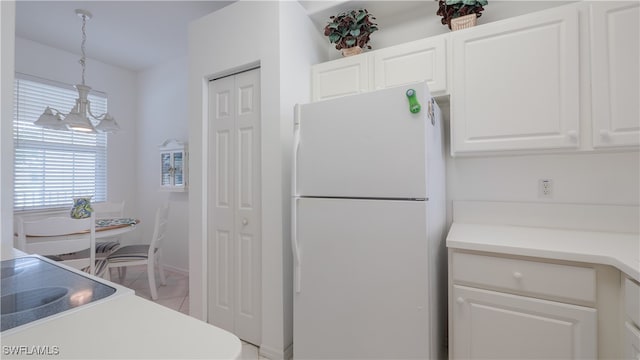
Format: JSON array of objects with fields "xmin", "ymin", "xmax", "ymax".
[{"xmin": 111, "ymin": 265, "xmax": 267, "ymax": 360}]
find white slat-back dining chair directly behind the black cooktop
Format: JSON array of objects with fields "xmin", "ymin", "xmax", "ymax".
[{"xmin": 16, "ymin": 215, "xmax": 106, "ymax": 276}]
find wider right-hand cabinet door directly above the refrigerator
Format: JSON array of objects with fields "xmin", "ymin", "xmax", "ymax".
[{"xmin": 373, "ymin": 36, "xmax": 447, "ymax": 95}]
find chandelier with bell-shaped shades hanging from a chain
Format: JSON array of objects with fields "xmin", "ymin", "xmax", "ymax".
[{"xmin": 34, "ymin": 9, "xmax": 120, "ymax": 133}]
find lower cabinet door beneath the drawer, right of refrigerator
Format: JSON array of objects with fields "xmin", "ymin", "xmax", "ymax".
[{"xmin": 450, "ymin": 285, "xmax": 597, "ymax": 359}]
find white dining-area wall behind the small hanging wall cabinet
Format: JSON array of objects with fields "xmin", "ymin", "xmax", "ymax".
[{"xmin": 135, "ymin": 56, "xmax": 189, "ymax": 273}]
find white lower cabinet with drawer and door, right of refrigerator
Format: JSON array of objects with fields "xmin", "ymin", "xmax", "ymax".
[{"xmin": 449, "ymin": 251, "xmax": 598, "ymax": 359}]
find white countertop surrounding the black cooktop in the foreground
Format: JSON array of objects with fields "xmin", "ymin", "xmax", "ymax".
[{"xmin": 0, "ymin": 252, "xmax": 242, "ymax": 359}]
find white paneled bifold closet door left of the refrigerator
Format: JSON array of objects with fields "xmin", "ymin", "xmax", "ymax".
[{"xmin": 208, "ymin": 70, "xmax": 262, "ymax": 344}]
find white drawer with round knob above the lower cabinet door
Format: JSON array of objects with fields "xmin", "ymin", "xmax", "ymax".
[{"xmin": 453, "ymin": 252, "xmax": 596, "ymax": 302}]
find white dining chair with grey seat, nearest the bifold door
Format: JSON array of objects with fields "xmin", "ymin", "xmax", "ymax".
[{"xmin": 105, "ymin": 204, "xmax": 169, "ymax": 300}]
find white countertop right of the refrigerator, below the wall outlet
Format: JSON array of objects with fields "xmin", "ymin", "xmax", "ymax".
[{"xmin": 447, "ymin": 222, "xmax": 640, "ymax": 282}]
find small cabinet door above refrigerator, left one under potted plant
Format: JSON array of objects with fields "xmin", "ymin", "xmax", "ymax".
[{"xmin": 311, "ymin": 54, "xmax": 369, "ymax": 101}]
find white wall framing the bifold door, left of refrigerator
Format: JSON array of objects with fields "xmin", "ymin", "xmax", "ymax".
[{"xmin": 189, "ymin": 1, "xmax": 324, "ymax": 358}]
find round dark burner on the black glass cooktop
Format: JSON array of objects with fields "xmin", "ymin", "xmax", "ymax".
[{"xmin": 0, "ymin": 286, "xmax": 69, "ymax": 315}]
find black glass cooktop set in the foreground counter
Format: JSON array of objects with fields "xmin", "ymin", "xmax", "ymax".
[{"xmin": 0, "ymin": 256, "xmax": 116, "ymax": 332}]
